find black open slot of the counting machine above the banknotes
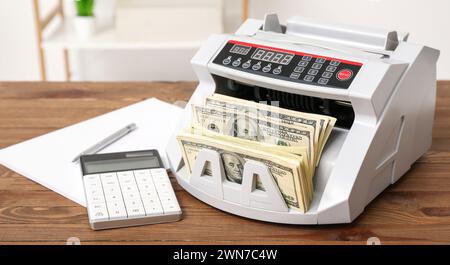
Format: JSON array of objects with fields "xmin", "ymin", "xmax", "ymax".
[{"xmin": 213, "ymin": 75, "xmax": 355, "ymax": 129}]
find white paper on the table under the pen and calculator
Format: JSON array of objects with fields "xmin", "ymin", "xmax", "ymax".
[{"xmin": 0, "ymin": 98, "xmax": 182, "ymax": 206}]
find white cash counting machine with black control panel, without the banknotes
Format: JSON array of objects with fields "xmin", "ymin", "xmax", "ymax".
[{"xmin": 167, "ymin": 14, "xmax": 439, "ymax": 224}]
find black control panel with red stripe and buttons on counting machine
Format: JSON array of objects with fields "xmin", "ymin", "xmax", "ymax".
[{"xmin": 213, "ymin": 40, "xmax": 362, "ymax": 89}]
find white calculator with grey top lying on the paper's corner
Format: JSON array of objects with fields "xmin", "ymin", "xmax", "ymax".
[{"xmin": 80, "ymin": 150, "xmax": 181, "ymax": 230}]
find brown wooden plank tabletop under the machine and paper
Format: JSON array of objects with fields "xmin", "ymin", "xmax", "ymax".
[{"xmin": 0, "ymin": 82, "xmax": 450, "ymax": 244}]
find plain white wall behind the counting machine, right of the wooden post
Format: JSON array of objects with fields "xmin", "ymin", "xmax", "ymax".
[{"xmin": 250, "ymin": 0, "xmax": 450, "ymax": 80}]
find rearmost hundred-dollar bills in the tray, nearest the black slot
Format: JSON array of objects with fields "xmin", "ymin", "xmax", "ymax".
[{"xmin": 204, "ymin": 94, "xmax": 336, "ymax": 165}]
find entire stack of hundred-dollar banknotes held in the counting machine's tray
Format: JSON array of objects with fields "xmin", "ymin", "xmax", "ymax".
[{"xmin": 177, "ymin": 94, "xmax": 336, "ymax": 212}]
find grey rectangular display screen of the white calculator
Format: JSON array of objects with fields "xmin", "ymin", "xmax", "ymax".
[{"xmin": 84, "ymin": 156, "xmax": 162, "ymax": 174}]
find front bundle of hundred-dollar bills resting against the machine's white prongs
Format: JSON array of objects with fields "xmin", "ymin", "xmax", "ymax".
[{"xmin": 177, "ymin": 133, "xmax": 311, "ymax": 212}]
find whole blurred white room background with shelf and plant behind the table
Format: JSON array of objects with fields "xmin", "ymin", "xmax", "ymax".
[{"xmin": 0, "ymin": 0, "xmax": 450, "ymax": 81}]
